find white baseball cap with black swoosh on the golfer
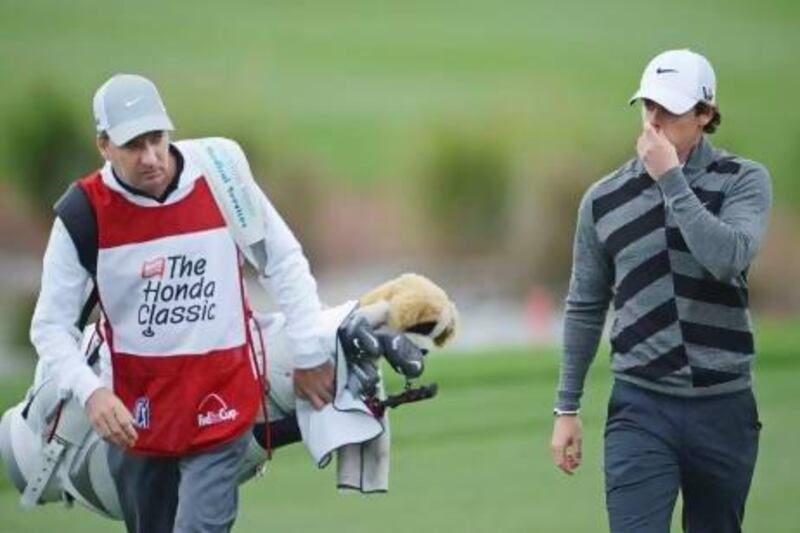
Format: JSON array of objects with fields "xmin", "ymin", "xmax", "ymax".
[{"xmin": 630, "ymin": 49, "xmax": 717, "ymax": 115}]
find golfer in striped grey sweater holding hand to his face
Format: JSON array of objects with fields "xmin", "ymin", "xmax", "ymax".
[{"xmin": 552, "ymin": 50, "xmax": 771, "ymax": 533}]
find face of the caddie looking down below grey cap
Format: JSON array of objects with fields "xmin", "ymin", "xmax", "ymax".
[{"xmin": 97, "ymin": 131, "xmax": 174, "ymax": 197}]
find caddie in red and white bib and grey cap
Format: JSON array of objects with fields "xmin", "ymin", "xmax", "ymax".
[{"xmin": 31, "ymin": 74, "xmax": 333, "ymax": 533}]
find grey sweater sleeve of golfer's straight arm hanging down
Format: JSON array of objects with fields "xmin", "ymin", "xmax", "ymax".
[{"xmin": 556, "ymin": 188, "xmax": 614, "ymax": 411}]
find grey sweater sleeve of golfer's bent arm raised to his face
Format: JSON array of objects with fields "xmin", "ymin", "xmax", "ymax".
[{"xmin": 658, "ymin": 161, "xmax": 772, "ymax": 281}]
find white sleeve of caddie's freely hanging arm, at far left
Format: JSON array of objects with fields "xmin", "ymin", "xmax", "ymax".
[{"xmin": 30, "ymin": 218, "xmax": 102, "ymax": 405}]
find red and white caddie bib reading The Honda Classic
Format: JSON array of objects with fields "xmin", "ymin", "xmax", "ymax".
[{"xmin": 79, "ymin": 173, "xmax": 260, "ymax": 455}]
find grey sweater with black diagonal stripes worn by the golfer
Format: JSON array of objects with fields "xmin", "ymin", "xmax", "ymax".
[{"xmin": 556, "ymin": 138, "xmax": 772, "ymax": 410}]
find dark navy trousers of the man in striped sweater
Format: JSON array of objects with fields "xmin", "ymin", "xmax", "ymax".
[{"xmin": 605, "ymin": 380, "xmax": 761, "ymax": 533}]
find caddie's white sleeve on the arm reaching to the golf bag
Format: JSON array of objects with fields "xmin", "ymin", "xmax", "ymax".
[{"xmin": 250, "ymin": 188, "xmax": 328, "ymax": 368}]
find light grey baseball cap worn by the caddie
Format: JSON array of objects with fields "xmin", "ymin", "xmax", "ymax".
[{"xmin": 93, "ymin": 74, "xmax": 175, "ymax": 146}]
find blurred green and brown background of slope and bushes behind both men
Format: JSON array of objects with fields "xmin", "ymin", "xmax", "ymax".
[{"xmin": 0, "ymin": 0, "xmax": 800, "ymax": 332}]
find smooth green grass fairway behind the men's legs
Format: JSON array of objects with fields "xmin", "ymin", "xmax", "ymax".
[{"xmin": 0, "ymin": 318, "xmax": 800, "ymax": 533}]
